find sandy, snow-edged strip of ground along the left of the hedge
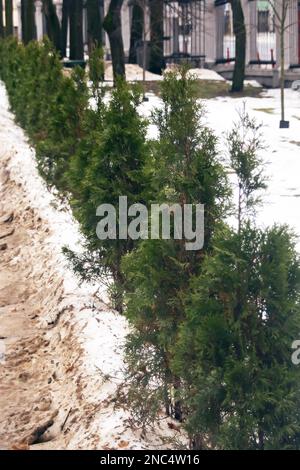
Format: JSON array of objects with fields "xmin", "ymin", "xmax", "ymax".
[{"xmin": 0, "ymin": 83, "xmax": 186, "ymax": 449}]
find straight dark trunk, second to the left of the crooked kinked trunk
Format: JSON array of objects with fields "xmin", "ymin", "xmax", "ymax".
[{"xmin": 70, "ymin": 0, "xmax": 84, "ymax": 60}]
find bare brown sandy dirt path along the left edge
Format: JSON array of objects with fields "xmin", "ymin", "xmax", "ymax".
[{"xmin": 0, "ymin": 160, "xmax": 74, "ymax": 448}]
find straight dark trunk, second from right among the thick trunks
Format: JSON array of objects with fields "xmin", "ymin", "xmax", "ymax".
[{"xmin": 149, "ymin": 0, "xmax": 165, "ymax": 74}]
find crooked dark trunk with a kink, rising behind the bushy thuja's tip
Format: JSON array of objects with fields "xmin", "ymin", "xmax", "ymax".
[{"xmin": 103, "ymin": 0, "xmax": 125, "ymax": 81}]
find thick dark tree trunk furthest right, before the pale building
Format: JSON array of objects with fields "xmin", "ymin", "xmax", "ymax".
[{"xmin": 230, "ymin": 0, "xmax": 246, "ymax": 92}]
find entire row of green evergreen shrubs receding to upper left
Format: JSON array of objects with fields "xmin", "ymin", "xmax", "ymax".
[{"xmin": 0, "ymin": 35, "xmax": 300, "ymax": 449}]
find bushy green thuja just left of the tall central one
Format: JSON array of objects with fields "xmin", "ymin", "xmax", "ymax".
[{"xmin": 69, "ymin": 81, "xmax": 149, "ymax": 310}]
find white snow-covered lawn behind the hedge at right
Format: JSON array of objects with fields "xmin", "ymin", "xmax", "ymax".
[{"xmin": 143, "ymin": 89, "xmax": 300, "ymax": 250}]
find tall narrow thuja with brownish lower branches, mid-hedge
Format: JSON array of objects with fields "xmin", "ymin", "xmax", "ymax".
[{"xmin": 123, "ymin": 68, "xmax": 229, "ymax": 426}]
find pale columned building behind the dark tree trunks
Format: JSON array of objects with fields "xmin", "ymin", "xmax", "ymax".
[{"xmin": 2, "ymin": 0, "xmax": 300, "ymax": 86}]
